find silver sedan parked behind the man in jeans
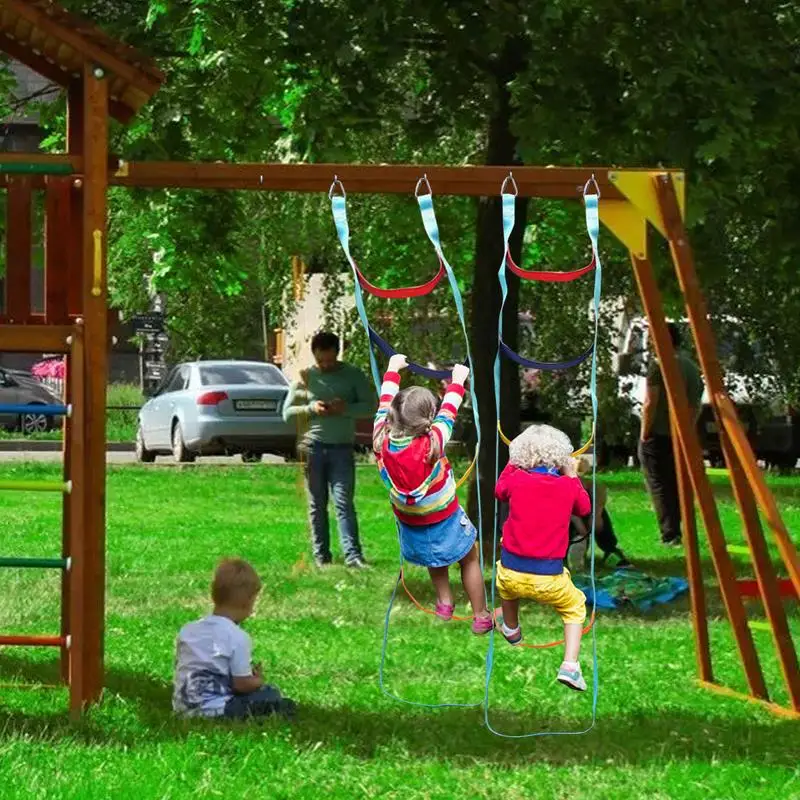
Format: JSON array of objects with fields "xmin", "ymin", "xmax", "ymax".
[{"xmin": 136, "ymin": 361, "xmax": 296, "ymax": 462}]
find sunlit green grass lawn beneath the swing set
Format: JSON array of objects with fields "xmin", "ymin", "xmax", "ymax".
[{"xmin": 0, "ymin": 465, "xmax": 800, "ymax": 800}]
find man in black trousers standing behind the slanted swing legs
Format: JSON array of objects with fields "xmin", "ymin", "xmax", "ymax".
[{"xmin": 639, "ymin": 322, "xmax": 703, "ymax": 546}]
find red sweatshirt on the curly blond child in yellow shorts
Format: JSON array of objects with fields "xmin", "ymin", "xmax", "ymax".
[{"xmin": 494, "ymin": 464, "xmax": 592, "ymax": 558}]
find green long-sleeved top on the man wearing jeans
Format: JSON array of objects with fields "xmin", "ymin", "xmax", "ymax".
[{"xmin": 283, "ymin": 362, "xmax": 377, "ymax": 444}]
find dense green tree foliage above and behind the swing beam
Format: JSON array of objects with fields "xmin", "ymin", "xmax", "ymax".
[{"xmin": 26, "ymin": 0, "xmax": 800, "ymax": 412}]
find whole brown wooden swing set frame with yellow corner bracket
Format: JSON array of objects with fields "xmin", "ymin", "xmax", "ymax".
[{"xmin": 0, "ymin": 0, "xmax": 800, "ymax": 718}]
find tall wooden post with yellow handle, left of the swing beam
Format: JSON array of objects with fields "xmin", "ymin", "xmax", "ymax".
[{"xmin": 82, "ymin": 64, "xmax": 108, "ymax": 703}]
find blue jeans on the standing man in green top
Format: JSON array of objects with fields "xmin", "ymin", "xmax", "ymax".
[{"xmin": 306, "ymin": 442, "xmax": 362, "ymax": 562}]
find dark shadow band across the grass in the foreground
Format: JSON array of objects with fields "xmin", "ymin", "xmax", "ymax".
[{"xmin": 0, "ymin": 655, "xmax": 800, "ymax": 768}]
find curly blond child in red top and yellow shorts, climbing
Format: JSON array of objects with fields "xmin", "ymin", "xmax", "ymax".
[{"xmin": 495, "ymin": 425, "xmax": 591, "ymax": 692}]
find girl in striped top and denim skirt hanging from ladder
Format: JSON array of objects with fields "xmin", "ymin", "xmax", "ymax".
[{"xmin": 372, "ymin": 354, "xmax": 494, "ymax": 634}]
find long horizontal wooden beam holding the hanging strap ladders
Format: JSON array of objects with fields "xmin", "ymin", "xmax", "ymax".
[{"xmin": 110, "ymin": 161, "xmax": 680, "ymax": 200}]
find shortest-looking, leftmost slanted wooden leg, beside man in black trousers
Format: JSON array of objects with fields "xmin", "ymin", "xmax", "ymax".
[{"xmin": 670, "ymin": 414, "xmax": 714, "ymax": 683}]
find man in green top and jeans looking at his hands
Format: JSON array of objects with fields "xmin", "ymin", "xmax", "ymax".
[{"xmin": 283, "ymin": 332, "xmax": 376, "ymax": 568}]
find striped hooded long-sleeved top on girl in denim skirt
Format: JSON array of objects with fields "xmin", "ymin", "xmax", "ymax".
[{"xmin": 373, "ymin": 372, "xmax": 464, "ymax": 525}]
